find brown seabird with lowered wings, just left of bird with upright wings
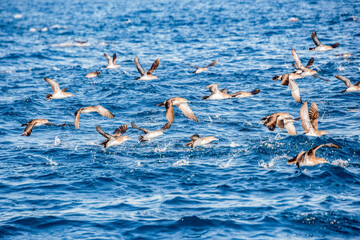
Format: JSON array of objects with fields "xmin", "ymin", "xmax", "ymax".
[{"xmin": 261, "ymin": 112, "xmax": 299, "ymax": 135}]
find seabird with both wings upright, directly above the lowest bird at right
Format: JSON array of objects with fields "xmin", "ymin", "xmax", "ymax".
[{"xmin": 300, "ymin": 102, "xmax": 329, "ymax": 137}]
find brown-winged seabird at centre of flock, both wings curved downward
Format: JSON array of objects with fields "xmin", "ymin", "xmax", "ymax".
[{"xmin": 157, "ymin": 97, "xmax": 199, "ymax": 123}]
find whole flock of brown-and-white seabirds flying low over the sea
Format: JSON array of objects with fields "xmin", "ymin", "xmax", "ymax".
[{"xmin": 22, "ymin": 31, "xmax": 360, "ymax": 169}]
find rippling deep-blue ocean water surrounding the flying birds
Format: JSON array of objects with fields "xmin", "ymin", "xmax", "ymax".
[{"xmin": 0, "ymin": 0, "xmax": 360, "ymax": 239}]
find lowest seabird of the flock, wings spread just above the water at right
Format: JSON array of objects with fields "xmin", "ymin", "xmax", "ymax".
[{"xmin": 287, "ymin": 143, "xmax": 341, "ymax": 170}]
